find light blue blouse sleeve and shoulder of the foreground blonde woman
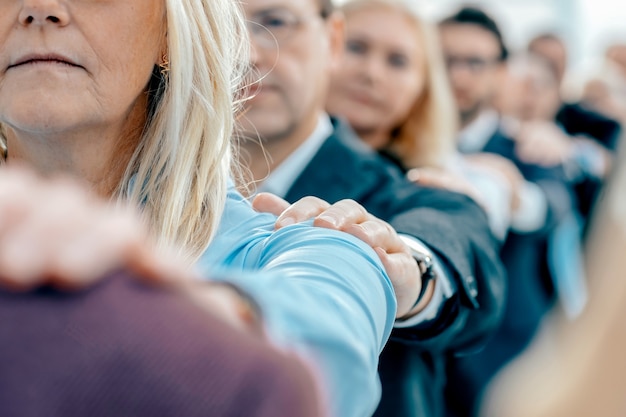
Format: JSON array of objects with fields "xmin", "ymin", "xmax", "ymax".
[{"xmin": 198, "ymin": 188, "xmax": 396, "ymax": 417}]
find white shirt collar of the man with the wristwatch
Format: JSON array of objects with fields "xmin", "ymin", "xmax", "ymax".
[{"xmin": 257, "ymin": 113, "xmax": 333, "ymax": 197}]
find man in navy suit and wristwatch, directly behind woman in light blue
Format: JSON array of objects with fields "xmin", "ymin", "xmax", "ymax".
[{"xmin": 236, "ymin": 0, "xmax": 505, "ymax": 417}]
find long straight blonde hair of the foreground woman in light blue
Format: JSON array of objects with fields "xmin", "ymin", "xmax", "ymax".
[{"xmin": 0, "ymin": 0, "xmax": 248, "ymax": 261}]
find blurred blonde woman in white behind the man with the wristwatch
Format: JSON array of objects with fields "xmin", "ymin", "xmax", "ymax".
[{"xmin": 327, "ymin": 0, "xmax": 522, "ymax": 239}]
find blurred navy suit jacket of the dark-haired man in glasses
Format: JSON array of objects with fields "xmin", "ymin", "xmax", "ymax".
[{"xmin": 446, "ymin": 130, "xmax": 573, "ymax": 417}]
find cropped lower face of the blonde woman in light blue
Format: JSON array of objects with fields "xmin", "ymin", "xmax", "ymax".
[{"xmin": 0, "ymin": 0, "xmax": 165, "ymax": 134}]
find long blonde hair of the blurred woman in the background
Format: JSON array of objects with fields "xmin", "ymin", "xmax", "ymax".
[{"xmin": 341, "ymin": 0, "xmax": 458, "ymax": 168}]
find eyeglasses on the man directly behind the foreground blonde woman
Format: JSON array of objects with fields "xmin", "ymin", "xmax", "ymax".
[{"xmin": 247, "ymin": 8, "xmax": 324, "ymax": 49}]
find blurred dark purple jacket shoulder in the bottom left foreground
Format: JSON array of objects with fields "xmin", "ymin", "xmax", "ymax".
[{"xmin": 0, "ymin": 270, "xmax": 321, "ymax": 417}]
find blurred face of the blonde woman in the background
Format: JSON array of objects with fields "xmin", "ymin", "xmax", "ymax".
[{"xmin": 327, "ymin": 8, "xmax": 426, "ymax": 148}]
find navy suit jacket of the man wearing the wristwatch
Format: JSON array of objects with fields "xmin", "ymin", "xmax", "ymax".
[{"xmin": 286, "ymin": 121, "xmax": 505, "ymax": 417}]
